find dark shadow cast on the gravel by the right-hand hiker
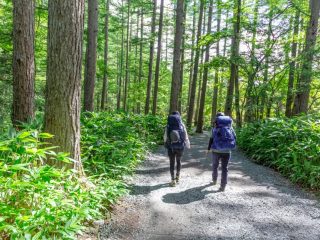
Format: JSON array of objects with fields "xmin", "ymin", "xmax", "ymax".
[{"xmin": 162, "ymin": 184, "xmax": 218, "ymax": 204}]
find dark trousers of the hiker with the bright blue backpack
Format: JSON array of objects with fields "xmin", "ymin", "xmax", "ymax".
[{"xmin": 212, "ymin": 152, "xmax": 231, "ymax": 186}]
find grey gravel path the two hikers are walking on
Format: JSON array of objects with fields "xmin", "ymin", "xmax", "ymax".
[{"xmin": 100, "ymin": 132, "xmax": 320, "ymax": 240}]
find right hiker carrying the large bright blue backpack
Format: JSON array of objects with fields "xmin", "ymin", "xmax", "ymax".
[{"xmin": 207, "ymin": 112, "xmax": 236, "ymax": 192}]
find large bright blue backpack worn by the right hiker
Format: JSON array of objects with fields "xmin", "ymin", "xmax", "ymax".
[{"xmin": 211, "ymin": 116, "xmax": 236, "ymax": 151}]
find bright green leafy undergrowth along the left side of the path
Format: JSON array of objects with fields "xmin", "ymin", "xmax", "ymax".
[{"xmin": 0, "ymin": 113, "xmax": 163, "ymax": 239}]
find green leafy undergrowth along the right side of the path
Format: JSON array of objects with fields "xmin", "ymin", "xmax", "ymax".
[{"xmin": 238, "ymin": 114, "xmax": 320, "ymax": 190}]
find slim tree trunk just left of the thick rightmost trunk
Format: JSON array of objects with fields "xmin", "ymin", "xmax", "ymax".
[{"xmin": 286, "ymin": 10, "xmax": 300, "ymax": 117}]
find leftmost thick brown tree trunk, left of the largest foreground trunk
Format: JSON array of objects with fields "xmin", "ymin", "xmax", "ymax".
[{"xmin": 12, "ymin": 0, "xmax": 35, "ymax": 126}]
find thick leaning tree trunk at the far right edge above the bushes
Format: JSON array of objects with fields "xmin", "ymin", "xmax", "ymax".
[{"xmin": 293, "ymin": 0, "xmax": 320, "ymax": 115}]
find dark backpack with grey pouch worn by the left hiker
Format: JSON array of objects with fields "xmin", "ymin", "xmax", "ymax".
[{"xmin": 166, "ymin": 114, "xmax": 186, "ymax": 150}]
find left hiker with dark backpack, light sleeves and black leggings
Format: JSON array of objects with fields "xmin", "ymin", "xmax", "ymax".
[{"xmin": 163, "ymin": 111, "xmax": 190, "ymax": 187}]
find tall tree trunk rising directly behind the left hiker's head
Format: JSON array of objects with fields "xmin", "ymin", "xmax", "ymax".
[{"xmin": 170, "ymin": 0, "xmax": 184, "ymax": 112}]
